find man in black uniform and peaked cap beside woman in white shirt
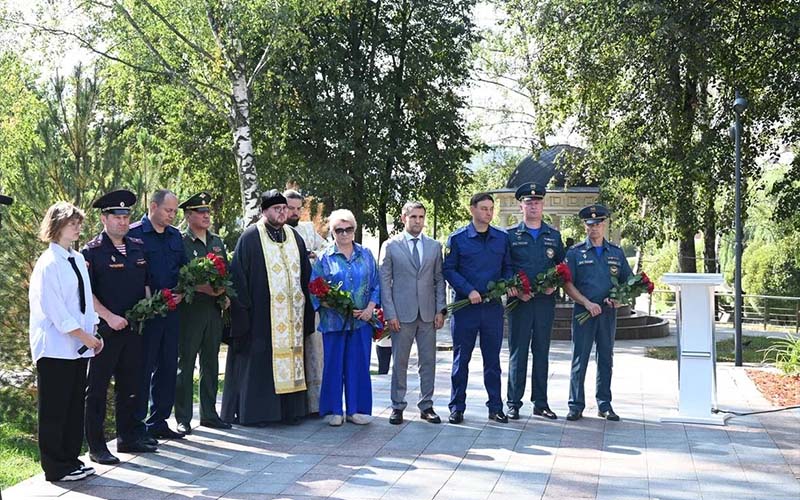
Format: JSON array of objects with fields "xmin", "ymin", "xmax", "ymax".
[{"xmin": 82, "ymin": 189, "xmax": 156, "ymax": 464}]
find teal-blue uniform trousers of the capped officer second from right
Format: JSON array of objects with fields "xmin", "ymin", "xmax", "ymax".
[{"xmin": 507, "ymin": 296, "xmax": 556, "ymax": 408}]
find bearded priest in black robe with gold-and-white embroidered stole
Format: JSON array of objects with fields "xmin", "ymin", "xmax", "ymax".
[{"xmin": 221, "ymin": 189, "xmax": 314, "ymax": 426}]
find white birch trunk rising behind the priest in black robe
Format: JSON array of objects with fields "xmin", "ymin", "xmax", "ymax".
[{"xmin": 230, "ymin": 70, "xmax": 261, "ymax": 226}]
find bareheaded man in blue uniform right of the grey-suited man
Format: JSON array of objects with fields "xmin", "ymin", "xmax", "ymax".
[{"xmin": 442, "ymin": 193, "xmax": 515, "ymax": 424}]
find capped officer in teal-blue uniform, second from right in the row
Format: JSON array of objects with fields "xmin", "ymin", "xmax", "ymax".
[{"xmin": 506, "ymin": 182, "xmax": 564, "ymax": 420}]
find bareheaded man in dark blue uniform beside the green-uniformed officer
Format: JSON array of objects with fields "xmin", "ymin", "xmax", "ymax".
[{"xmin": 130, "ymin": 189, "xmax": 188, "ymax": 439}]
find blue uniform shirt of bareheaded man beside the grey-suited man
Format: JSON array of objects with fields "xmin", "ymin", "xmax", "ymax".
[{"xmin": 442, "ymin": 222, "xmax": 514, "ymax": 300}]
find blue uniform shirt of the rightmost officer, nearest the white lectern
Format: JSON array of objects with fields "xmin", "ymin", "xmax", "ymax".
[{"xmin": 564, "ymin": 238, "xmax": 632, "ymax": 311}]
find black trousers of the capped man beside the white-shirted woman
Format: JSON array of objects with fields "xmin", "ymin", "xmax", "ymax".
[{"xmin": 86, "ymin": 331, "xmax": 144, "ymax": 453}]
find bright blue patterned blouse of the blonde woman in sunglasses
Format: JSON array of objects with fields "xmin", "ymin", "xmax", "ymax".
[{"xmin": 311, "ymin": 243, "xmax": 381, "ymax": 332}]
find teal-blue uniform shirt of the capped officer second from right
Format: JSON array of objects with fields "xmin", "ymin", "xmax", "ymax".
[{"xmin": 508, "ymin": 222, "xmax": 565, "ymax": 298}]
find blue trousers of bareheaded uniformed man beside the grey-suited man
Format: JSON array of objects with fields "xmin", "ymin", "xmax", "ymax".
[{"xmin": 448, "ymin": 303, "xmax": 503, "ymax": 412}]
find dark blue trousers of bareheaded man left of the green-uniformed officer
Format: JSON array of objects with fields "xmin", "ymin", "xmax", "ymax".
[{"xmin": 136, "ymin": 311, "xmax": 180, "ymax": 430}]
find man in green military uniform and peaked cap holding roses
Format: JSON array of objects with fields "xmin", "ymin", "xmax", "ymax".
[{"xmin": 175, "ymin": 192, "xmax": 231, "ymax": 434}]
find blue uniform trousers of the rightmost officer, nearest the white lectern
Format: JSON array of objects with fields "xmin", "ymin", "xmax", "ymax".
[{"xmin": 569, "ymin": 305, "xmax": 617, "ymax": 411}]
